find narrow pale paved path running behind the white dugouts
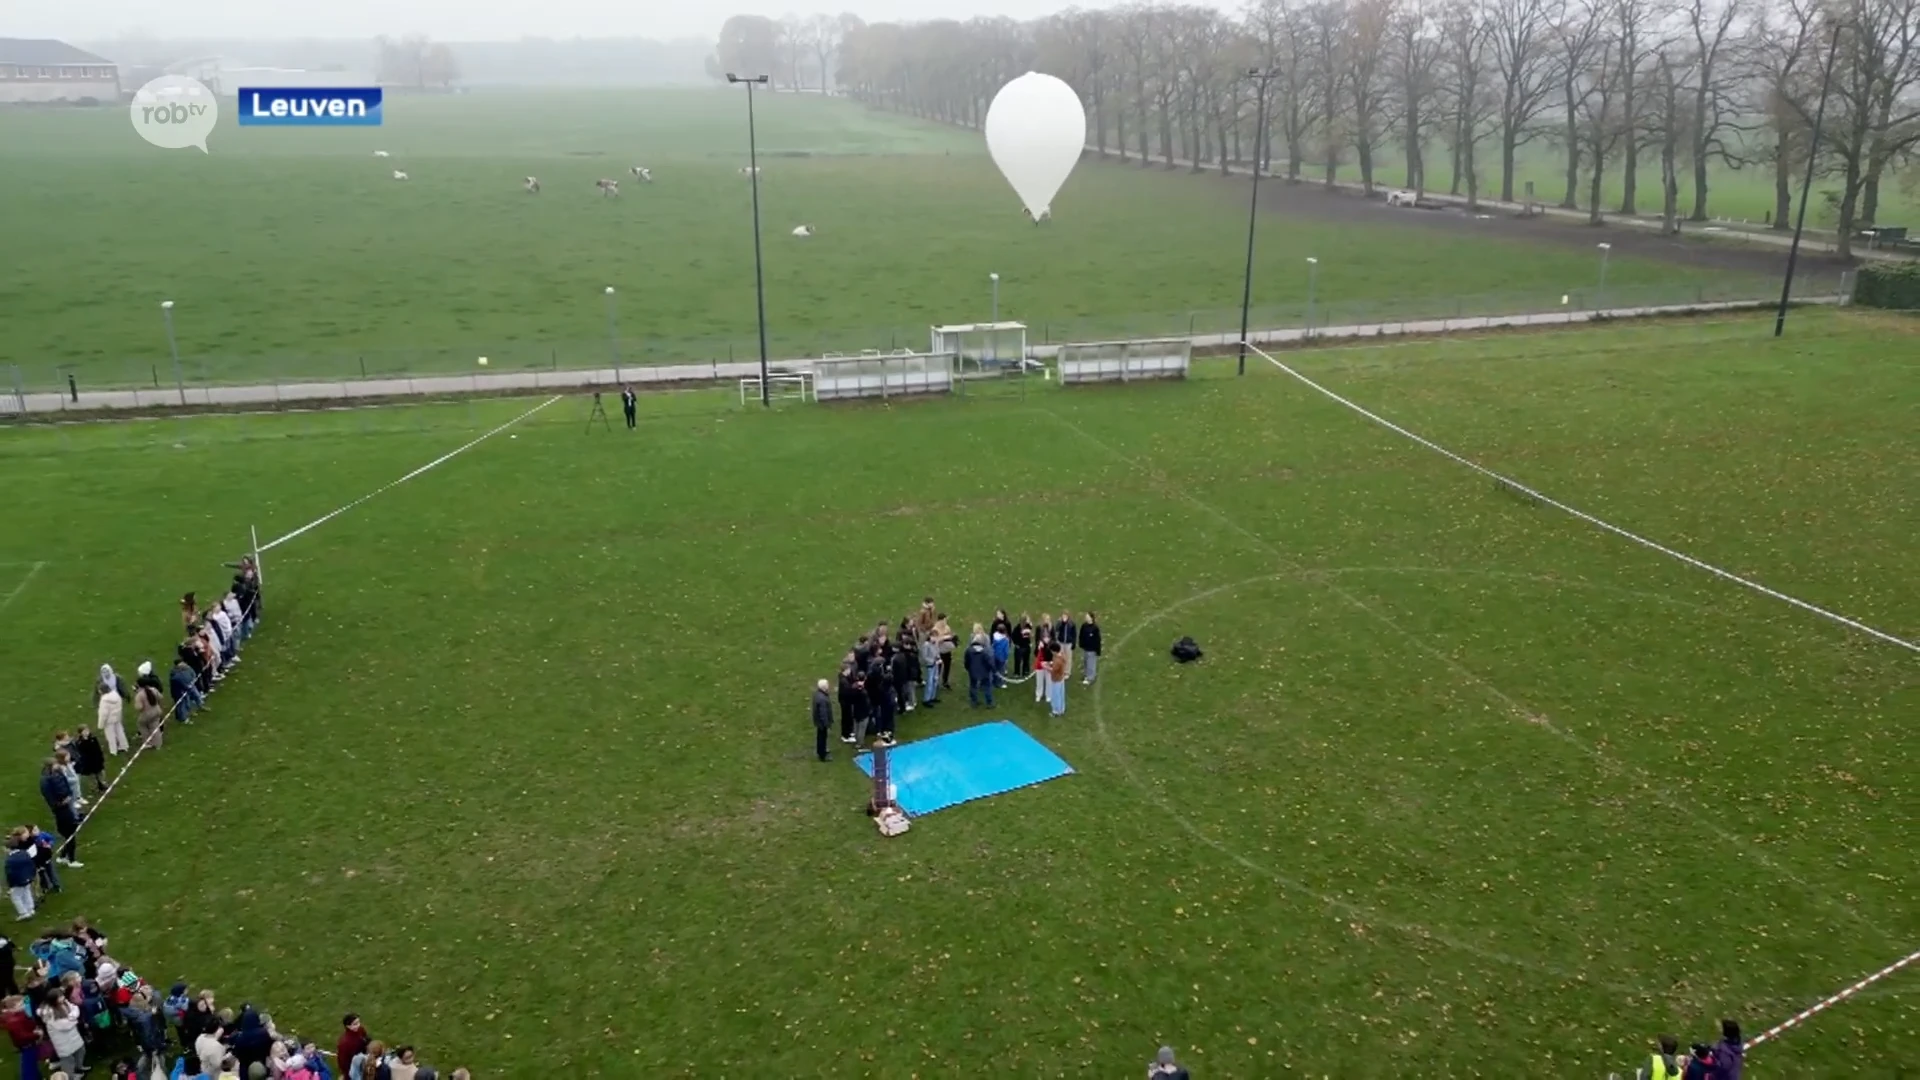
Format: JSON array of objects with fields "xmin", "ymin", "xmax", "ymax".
[{"xmin": 0, "ymin": 300, "xmax": 1804, "ymax": 415}]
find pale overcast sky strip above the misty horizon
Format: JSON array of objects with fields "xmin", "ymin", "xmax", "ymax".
[{"xmin": 15, "ymin": 0, "xmax": 1102, "ymax": 40}]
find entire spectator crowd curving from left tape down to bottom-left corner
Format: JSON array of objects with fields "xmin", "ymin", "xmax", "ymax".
[{"xmin": 0, "ymin": 557, "xmax": 470, "ymax": 1080}]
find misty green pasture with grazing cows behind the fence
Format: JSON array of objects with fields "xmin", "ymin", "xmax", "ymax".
[{"xmin": 0, "ymin": 90, "xmax": 1766, "ymax": 390}]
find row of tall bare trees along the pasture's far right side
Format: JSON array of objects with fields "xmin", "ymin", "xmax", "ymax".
[{"xmin": 756, "ymin": 0, "xmax": 1920, "ymax": 252}]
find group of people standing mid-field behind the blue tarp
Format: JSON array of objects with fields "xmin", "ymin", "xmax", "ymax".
[{"xmin": 812, "ymin": 596, "xmax": 1100, "ymax": 761}]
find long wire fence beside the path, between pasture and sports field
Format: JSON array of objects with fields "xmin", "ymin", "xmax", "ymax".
[{"xmin": 0, "ymin": 273, "xmax": 1851, "ymax": 411}]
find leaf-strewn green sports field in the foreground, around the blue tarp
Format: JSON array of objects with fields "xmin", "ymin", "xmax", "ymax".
[{"xmin": 0, "ymin": 313, "xmax": 1920, "ymax": 1076}]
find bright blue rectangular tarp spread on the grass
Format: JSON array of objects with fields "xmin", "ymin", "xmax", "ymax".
[{"xmin": 854, "ymin": 721, "xmax": 1073, "ymax": 817}]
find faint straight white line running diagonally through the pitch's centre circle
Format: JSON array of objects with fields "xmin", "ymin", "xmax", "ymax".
[{"xmin": 1041, "ymin": 407, "xmax": 1895, "ymax": 942}]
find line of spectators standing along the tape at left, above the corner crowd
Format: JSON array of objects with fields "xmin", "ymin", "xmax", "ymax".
[{"xmin": 6, "ymin": 557, "xmax": 261, "ymax": 922}]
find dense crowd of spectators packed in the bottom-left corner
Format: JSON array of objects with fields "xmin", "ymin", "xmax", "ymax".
[{"xmin": 0, "ymin": 919, "xmax": 472, "ymax": 1080}]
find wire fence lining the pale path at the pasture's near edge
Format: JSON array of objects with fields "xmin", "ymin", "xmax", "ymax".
[{"xmin": 0, "ymin": 273, "xmax": 1849, "ymax": 415}]
